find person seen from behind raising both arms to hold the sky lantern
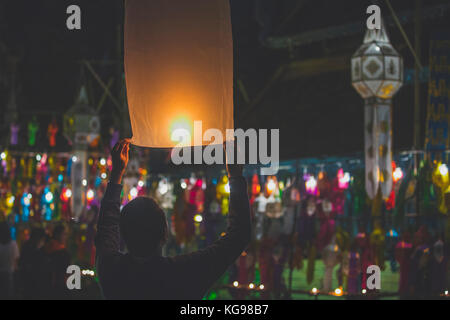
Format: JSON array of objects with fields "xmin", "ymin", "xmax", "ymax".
[{"xmin": 96, "ymin": 140, "xmax": 251, "ymax": 299}]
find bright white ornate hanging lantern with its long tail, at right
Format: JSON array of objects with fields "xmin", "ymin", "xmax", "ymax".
[{"xmin": 351, "ymin": 23, "xmax": 403, "ymax": 199}]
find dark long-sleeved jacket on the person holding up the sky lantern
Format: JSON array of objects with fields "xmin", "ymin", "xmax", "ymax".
[{"xmin": 96, "ymin": 177, "xmax": 251, "ymax": 299}]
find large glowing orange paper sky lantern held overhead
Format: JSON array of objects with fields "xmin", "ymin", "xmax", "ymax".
[{"xmin": 124, "ymin": 0, "xmax": 234, "ymax": 148}]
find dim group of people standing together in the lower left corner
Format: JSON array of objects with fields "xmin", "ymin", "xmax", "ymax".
[{"xmin": 0, "ymin": 222, "xmax": 71, "ymax": 299}]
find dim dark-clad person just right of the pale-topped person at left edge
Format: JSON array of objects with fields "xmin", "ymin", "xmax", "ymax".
[{"xmin": 19, "ymin": 228, "xmax": 47, "ymax": 299}]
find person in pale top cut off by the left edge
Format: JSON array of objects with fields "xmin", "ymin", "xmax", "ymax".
[{"xmin": 0, "ymin": 222, "xmax": 19, "ymax": 300}]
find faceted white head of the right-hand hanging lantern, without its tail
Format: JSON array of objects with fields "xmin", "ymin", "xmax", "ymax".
[{"xmin": 351, "ymin": 23, "xmax": 403, "ymax": 99}]
